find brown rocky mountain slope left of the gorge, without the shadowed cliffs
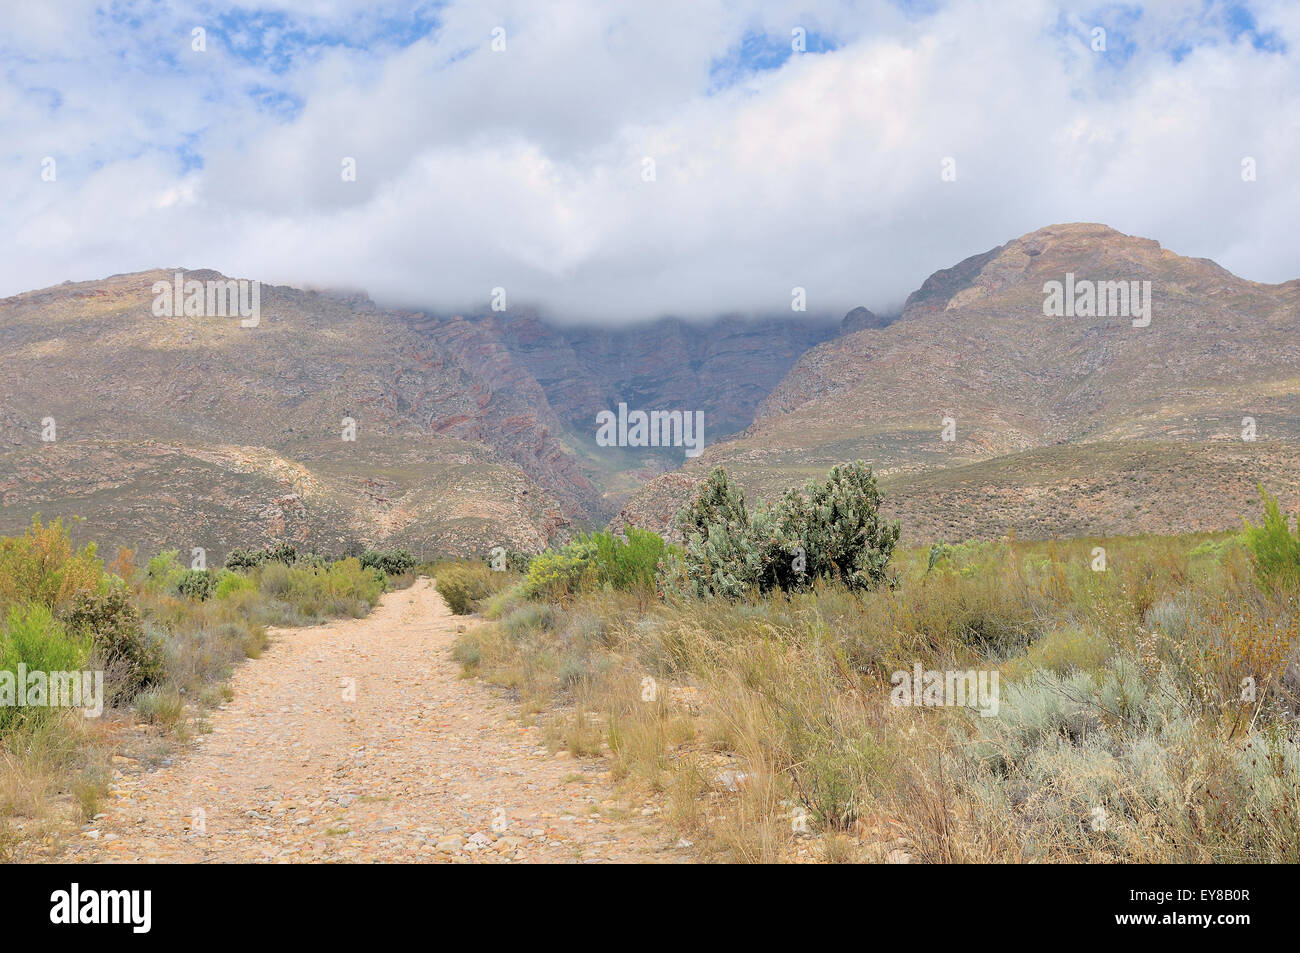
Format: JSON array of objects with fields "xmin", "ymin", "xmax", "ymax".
[{"xmin": 0, "ymin": 272, "xmax": 572, "ymax": 554}]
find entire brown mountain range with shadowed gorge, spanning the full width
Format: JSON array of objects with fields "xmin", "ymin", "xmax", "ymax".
[{"xmin": 0, "ymin": 224, "xmax": 1300, "ymax": 559}]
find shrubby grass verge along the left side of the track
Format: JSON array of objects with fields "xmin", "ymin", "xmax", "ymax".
[{"xmin": 0, "ymin": 520, "xmax": 415, "ymax": 861}]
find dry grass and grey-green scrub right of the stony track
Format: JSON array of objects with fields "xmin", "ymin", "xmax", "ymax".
[{"xmin": 456, "ymin": 534, "xmax": 1300, "ymax": 862}]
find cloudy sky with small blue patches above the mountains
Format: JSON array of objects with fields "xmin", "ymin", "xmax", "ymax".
[{"xmin": 0, "ymin": 0, "xmax": 1300, "ymax": 324}]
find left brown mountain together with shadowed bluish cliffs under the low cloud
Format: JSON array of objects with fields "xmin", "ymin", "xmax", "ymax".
[{"xmin": 0, "ymin": 269, "xmax": 835, "ymax": 558}]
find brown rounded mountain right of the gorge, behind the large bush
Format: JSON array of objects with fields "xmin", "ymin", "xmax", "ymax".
[{"xmin": 616, "ymin": 224, "xmax": 1300, "ymax": 541}]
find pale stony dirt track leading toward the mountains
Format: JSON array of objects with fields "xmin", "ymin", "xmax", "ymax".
[{"xmin": 62, "ymin": 579, "xmax": 692, "ymax": 863}]
